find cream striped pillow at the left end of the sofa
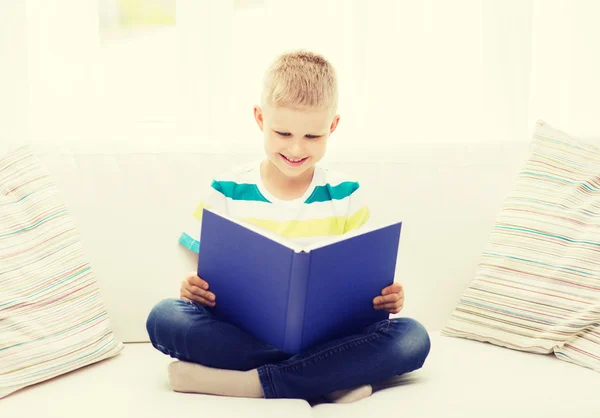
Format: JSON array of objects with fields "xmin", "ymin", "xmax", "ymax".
[{"xmin": 0, "ymin": 148, "xmax": 123, "ymax": 398}]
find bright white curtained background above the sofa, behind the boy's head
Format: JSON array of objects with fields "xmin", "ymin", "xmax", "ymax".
[{"xmin": 8, "ymin": 0, "xmax": 600, "ymax": 154}]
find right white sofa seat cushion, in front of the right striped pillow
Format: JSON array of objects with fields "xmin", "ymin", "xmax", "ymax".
[{"xmin": 313, "ymin": 332, "xmax": 600, "ymax": 418}]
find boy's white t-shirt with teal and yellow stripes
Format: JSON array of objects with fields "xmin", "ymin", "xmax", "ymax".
[{"xmin": 179, "ymin": 163, "xmax": 369, "ymax": 252}]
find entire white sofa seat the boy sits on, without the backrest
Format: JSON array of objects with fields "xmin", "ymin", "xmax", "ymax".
[{"xmin": 5, "ymin": 332, "xmax": 600, "ymax": 418}]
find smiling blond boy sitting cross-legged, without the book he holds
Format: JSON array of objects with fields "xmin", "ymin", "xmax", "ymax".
[{"xmin": 146, "ymin": 52, "xmax": 430, "ymax": 402}]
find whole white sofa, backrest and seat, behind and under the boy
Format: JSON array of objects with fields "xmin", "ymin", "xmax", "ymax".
[{"xmin": 0, "ymin": 141, "xmax": 600, "ymax": 418}]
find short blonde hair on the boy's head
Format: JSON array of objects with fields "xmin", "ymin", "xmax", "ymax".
[{"xmin": 262, "ymin": 51, "xmax": 338, "ymax": 114}]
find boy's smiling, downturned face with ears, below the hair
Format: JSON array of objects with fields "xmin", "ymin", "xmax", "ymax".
[{"xmin": 254, "ymin": 106, "xmax": 340, "ymax": 177}]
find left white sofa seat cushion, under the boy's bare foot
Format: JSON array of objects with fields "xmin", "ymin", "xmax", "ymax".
[{"xmin": 0, "ymin": 343, "xmax": 311, "ymax": 418}]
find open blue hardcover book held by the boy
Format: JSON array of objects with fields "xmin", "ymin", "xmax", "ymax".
[{"xmin": 198, "ymin": 209, "xmax": 402, "ymax": 354}]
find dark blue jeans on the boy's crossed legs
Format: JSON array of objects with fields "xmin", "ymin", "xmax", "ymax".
[{"xmin": 146, "ymin": 299, "xmax": 430, "ymax": 400}]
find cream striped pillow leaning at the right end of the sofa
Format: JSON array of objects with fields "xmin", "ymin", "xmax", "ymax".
[{"xmin": 442, "ymin": 121, "xmax": 600, "ymax": 371}]
